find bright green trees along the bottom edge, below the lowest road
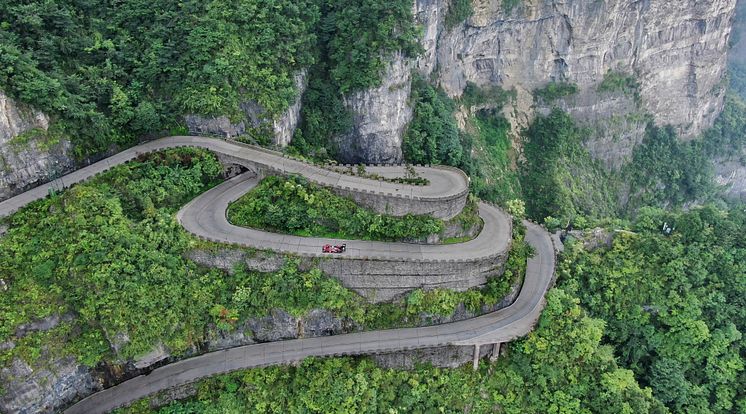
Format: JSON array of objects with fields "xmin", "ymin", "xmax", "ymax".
[{"xmin": 120, "ymin": 290, "xmax": 666, "ymax": 414}]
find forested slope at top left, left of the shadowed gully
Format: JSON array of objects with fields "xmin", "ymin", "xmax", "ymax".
[{"xmin": 0, "ymin": 0, "xmax": 319, "ymax": 157}]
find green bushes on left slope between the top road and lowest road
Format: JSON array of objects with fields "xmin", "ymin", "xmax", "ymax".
[{"xmin": 0, "ymin": 150, "xmax": 221, "ymax": 365}]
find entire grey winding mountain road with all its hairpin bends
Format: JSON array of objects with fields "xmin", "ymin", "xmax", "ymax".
[{"xmin": 0, "ymin": 137, "xmax": 555, "ymax": 413}]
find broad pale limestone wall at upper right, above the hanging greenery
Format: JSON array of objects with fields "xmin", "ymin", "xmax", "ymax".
[{"xmin": 437, "ymin": 0, "xmax": 736, "ymax": 137}]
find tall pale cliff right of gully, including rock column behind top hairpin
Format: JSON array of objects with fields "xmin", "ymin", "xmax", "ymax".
[{"xmin": 348, "ymin": 0, "xmax": 736, "ymax": 167}]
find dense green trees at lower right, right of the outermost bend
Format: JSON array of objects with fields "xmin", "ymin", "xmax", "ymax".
[{"xmin": 559, "ymin": 207, "xmax": 746, "ymax": 413}]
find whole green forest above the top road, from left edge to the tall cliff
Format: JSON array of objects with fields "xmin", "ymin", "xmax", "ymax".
[{"xmin": 0, "ymin": 0, "xmax": 419, "ymax": 157}]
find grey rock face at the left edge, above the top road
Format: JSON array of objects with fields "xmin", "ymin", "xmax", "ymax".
[{"xmin": 0, "ymin": 91, "xmax": 74, "ymax": 200}]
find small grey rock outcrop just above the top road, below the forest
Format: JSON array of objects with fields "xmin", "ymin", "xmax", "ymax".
[{"xmin": 184, "ymin": 70, "xmax": 308, "ymax": 147}]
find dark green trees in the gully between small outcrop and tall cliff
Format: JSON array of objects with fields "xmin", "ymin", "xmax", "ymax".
[{"xmin": 292, "ymin": 0, "xmax": 420, "ymax": 158}]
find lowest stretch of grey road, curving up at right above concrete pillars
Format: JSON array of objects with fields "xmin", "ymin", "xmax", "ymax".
[{"xmin": 65, "ymin": 222, "xmax": 556, "ymax": 414}]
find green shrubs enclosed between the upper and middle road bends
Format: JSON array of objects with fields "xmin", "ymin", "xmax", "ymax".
[{"xmin": 228, "ymin": 176, "xmax": 443, "ymax": 240}]
